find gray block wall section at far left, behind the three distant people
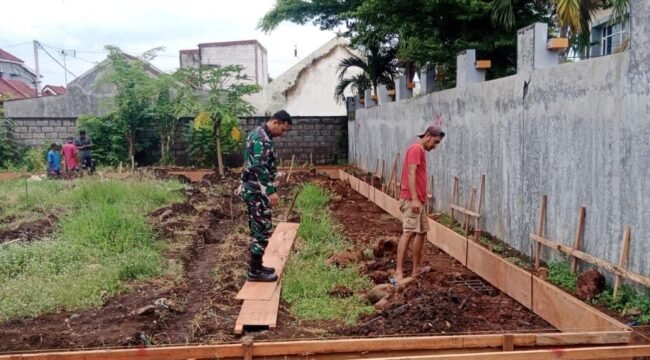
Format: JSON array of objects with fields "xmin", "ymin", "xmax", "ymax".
[{"xmin": 12, "ymin": 118, "xmax": 77, "ymax": 147}]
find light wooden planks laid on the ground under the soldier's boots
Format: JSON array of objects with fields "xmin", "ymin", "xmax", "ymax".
[{"xmin": 234, "ymin": 222, "xmax": 299, "ymax": 334}]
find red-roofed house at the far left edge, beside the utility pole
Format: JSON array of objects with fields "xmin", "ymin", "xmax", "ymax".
[{"xmin": 0, "ymin": 49, "xmax": 36, "ymax": 99}]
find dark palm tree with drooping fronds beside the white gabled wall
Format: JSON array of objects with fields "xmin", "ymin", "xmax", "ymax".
[{"xmin": 334, "ymin": 45, "xmax": 397, "ymax": 100}]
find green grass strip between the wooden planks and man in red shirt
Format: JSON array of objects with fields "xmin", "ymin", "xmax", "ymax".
[{"xmin": 282, "ymin": 184, "xmax": 373, "ymax": 323}]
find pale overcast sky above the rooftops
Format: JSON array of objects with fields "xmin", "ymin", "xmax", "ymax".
[{"xmin": 0, "ymin": 0, "xmax": 335, "ymax": 85}]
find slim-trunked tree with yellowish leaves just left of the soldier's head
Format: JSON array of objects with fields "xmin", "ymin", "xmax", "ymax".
[{"xmin": 176, "ymin": 65, "xmax": 260, "ymax": 176}]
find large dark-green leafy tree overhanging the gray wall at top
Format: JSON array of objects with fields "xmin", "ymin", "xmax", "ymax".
[{"xmin": 260, "ymin": 0, "xmax": 551, "ymax": 86}]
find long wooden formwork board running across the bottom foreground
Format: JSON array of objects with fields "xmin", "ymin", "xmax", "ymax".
[{"xmin": 0, "ymin": 331, "xmax": 636, "ymax": 360}]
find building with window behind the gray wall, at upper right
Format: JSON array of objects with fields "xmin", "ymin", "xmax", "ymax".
[{"xmin": 589, "ymin": 9, "xmax": 630, "ymax": 57}]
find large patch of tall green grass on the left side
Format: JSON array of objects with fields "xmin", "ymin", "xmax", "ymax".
[{"xmin": 0, "ymin": 179, "xmax": 182, "ymax": 321}]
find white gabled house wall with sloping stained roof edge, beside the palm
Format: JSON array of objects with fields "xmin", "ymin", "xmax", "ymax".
[{"xmin": 248, "ymin": 37, "xmax": 358, "ymax": 116}]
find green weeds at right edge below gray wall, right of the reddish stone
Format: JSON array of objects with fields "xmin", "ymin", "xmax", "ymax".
[{"xmin": 592, "ymin": 285, "xmax": 650, "ymax": 325}]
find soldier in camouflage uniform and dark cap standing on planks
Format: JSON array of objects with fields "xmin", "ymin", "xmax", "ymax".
[{"xmin": 241, "ymin": 110, "xmax": 291, "ymax": 281}]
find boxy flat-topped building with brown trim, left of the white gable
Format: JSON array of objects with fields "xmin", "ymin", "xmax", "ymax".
[{"xmin": 179, "ymin": 40, "xmax": 269, "ymax": 86}]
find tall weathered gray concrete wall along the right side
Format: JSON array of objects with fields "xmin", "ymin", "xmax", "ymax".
[{"xmin": 348, "ymin": 2, "xmax": 650, "ymax": 275}]
